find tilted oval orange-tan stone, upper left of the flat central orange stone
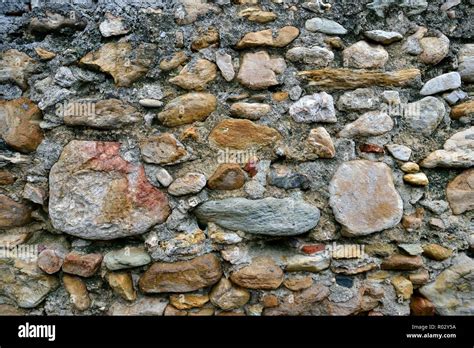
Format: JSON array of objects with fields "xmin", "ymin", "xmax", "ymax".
[{"xmin": 158, "ymin": 93, "xmax": 217, "ymax": 127}]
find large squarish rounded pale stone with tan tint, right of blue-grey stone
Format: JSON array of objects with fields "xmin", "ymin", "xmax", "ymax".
[{"xmin": 329, "ymin": 160, "xmax": 403, "ymax": 236}]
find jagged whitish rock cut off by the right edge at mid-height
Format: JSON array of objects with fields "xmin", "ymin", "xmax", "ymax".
[{"xmin": 421, "ymin": 127, "xmax": 474, "ymax": 168}]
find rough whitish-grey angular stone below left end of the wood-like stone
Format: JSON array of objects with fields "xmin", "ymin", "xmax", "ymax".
[{"xmin": 290, "ymin": 92, "xmax": 337, "ymax": 123}]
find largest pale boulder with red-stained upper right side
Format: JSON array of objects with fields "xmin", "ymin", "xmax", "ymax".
[{"xmin": 49, "ymin": 141, "xmax": 170, "ymax": 239}]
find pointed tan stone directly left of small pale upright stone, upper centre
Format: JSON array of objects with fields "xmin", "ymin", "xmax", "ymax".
[{"xmin": 169, "ymin": 59, "xmax": 217, "ymax": 91}]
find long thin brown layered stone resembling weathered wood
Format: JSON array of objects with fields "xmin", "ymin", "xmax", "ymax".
[{"xmin": 298, "ymin": 68, "xmax": 420, "ymax": 90}]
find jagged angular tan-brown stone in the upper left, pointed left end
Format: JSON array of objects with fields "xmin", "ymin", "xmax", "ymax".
[{"xmin": 79, "ymin": 42, "xmax": 156, "ymax": 87}]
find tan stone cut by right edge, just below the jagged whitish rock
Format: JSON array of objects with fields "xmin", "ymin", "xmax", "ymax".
[{"xmin": 446, "ymin": 169, "xmax": 474, "ymax": 214}]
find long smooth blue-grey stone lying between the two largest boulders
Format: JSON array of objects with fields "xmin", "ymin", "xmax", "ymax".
[{"xmin": 194, "ymin": 197, "xmax": 320, "ymax": 236}]
